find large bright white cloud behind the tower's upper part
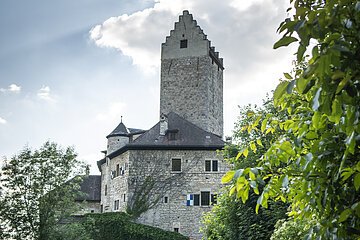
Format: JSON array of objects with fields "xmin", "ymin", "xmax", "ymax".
[{"xmin": 90, "ymin": 0, "xmax": 295, "ymax": 132}]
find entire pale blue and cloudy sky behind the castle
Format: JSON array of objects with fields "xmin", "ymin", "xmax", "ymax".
[{"xmin": 0, "ymin": 0, "xmax": 295, "ymax": 174}]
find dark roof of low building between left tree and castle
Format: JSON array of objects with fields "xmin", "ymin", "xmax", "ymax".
[{"xmin": 76, "ymin": 175, "xmax": 101, "ymax": 202}]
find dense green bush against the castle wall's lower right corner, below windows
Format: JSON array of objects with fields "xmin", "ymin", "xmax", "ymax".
[{"xmin": 202, "ymin": 188, "xmax": 287, "ymax": 240}]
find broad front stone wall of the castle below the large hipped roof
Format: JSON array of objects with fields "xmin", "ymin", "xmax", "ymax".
[{"xmin": 129, "ymin": 150, "xmax": 228, "ymax": 239}]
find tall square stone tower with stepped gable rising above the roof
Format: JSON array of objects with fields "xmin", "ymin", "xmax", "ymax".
[{"xmin": 160, "ymin": 11, "xmax": 224, "ymax": 136}]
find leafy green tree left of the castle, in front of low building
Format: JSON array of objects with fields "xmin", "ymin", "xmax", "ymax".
[{"xmin": 0, "ymin": 142, "xmax": 85, "ymax": 239}]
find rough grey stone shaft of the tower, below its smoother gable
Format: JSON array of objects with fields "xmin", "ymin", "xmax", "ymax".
[{"xmin": 160, "ymin": 56, "xmax": 223, "ymax": 136}]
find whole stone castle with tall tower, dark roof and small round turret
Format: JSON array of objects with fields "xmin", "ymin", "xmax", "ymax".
[{"xmin": 97, "ymin": 11, "xmax": 228, "ymax": 239}]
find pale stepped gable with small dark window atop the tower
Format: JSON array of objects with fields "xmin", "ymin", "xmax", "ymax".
[{"xmin": 161, "ymin": 10, "xmax": 224, "ymax": 70}]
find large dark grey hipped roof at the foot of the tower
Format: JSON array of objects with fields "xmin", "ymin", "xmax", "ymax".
[{"xmin": 108, "ymin": 112, "xmax": 225, "ymax": 158}]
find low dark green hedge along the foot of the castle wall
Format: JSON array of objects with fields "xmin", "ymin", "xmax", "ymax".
[{"xmin": 82, "ymin": 213, "xmax": 188, "ymax": 240}]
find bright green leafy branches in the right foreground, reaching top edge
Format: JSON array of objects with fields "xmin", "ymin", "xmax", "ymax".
[{"xmin": 223, "ymin": 0, "xmax": 360, "ymax": 239}]
